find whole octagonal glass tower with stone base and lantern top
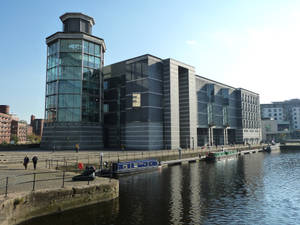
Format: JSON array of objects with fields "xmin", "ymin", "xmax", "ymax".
[{"xmin": 41, "ymin": 13, "xmax": 106, "ymax": 149}]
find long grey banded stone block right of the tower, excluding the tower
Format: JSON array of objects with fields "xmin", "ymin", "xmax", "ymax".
[{"xmin": 103, "ymin": 55, "xmax": 261, "ymax": 150}]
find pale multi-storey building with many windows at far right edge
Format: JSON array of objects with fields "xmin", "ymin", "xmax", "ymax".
[{"xmin": 261, "ymin": 99, "xmax": 300, "ymax": 138}]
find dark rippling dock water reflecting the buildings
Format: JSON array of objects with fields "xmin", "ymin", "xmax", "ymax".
[{"xmin": 22, "ymin": 151, "xmax": 300, "ymax": 225}]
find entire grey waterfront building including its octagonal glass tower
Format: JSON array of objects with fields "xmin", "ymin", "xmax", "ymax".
[{"xmin": 41, "ymin": 13, "xmax": 261, "ymax": 150}]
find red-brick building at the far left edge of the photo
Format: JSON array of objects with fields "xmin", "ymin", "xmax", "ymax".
[{"xmin": 0, "ymin": 105, "xmax": 12, "ymax": 144}]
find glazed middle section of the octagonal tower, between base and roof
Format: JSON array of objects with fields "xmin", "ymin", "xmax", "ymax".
[{"xmin": 45, "ymin": 39, "xmax": 101, "ymax": 122}]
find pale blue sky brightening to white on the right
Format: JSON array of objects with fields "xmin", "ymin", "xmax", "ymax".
[{"xmin": 0, "ymin": 0, "xmax": 300, "ymax": 121}]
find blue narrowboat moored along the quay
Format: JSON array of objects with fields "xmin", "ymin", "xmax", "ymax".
[{"xmin": 100, "ymin": 159, "xmax": 159, "ymax": 176}]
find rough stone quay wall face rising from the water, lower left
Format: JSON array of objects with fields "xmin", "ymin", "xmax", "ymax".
[{"xmin": 0, "ymin": 178, "xmax": 119, "ymax": 225}]
